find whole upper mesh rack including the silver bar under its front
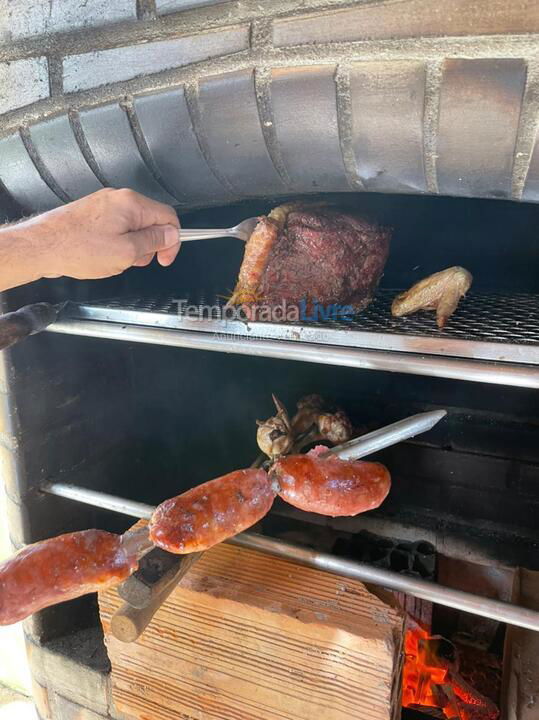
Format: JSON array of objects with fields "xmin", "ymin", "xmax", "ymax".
[{"xmin": 50, "ymin": 289, "xmax": 539, "ymax": 388}]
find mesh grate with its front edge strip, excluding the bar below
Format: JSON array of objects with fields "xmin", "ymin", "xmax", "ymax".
[{"xmin": 69, "ymin": 290, "xmax": 539, "ymax": 364}]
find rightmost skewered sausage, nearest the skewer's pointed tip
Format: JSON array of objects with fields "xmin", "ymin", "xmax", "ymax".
[{"xmin": 270, "ymin": 448, "xmax": 391, "ymax": 517}]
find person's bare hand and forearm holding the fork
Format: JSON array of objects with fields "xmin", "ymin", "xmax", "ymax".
[{"xmin": 0, "ymin": 188, "xmax": 180, "ymax": 291}]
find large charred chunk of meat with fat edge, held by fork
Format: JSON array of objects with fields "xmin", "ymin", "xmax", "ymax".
[{"xmin": 230, "ymin": 204, "xmax": 390, "ymax": 314}]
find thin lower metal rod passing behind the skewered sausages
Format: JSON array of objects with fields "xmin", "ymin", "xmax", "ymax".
[{"xmin": 42, "ymin": 483, "xmax": 539, "ymax": 632}]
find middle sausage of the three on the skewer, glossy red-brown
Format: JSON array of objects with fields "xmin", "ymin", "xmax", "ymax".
[{"xmin": 150, "ymin": 469, "xmax": 275, "ymax": 554}]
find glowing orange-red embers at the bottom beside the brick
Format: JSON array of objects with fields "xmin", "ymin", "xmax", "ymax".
[{"xmin": 402, "ymin": 625, "xmax": 500, "ymax": 720}]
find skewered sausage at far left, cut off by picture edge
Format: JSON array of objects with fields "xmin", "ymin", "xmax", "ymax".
[{"xmin": 0, "ymin": 530, "xmax": 138, "ymax": 625}]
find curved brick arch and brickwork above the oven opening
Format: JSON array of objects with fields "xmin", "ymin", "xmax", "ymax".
[{"xmin": 0, "ymin": 0, "xmax": 539, "ymax": 210}]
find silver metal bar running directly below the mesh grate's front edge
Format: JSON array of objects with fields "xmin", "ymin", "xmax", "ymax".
[{"xmin": 48, "ymin": 319, "xmax": 539, "ymax": 389}]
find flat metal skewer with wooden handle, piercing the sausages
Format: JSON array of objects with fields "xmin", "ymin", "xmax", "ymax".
[{"xmin": 111, "ymin": 410, "xmax": 447, "ymax": 642}]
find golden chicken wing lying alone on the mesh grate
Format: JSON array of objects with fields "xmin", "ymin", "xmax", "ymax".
[{"xmin": 391, "ymin": 265, "xmax": 473, "ymax": 329}]
